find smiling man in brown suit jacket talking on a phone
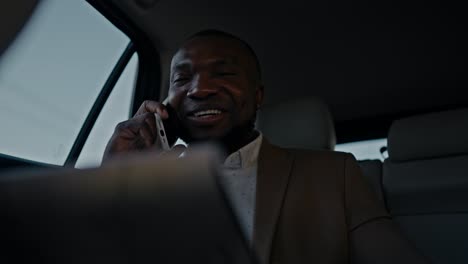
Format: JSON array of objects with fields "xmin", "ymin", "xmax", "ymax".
[{"xmin": 104, "ymin": 30, "xmax": 426, "ymax": 264}]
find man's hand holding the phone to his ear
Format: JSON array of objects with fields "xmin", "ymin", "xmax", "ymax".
[{"xmin": 103, "ymin": 101, "xmax": 169, "ymax": 161}]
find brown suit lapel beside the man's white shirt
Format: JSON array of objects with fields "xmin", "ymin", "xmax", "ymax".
[{"xmin": 253, "ymin": 139, "xmax": 293, "ymax": 263}]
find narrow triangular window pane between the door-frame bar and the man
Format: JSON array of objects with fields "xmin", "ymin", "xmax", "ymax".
[{"xmin": 75, "ymin": 53, "xmax": 138, "ymax": 168}]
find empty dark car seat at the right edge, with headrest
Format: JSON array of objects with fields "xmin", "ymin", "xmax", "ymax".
[{"xmin": 383, "ymin": 108, "xmax": 468, "ymax": 264}]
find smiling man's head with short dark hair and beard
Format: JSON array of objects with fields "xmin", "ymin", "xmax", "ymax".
[{"xmin": 169, "ymin": 36, "xmax": 263, "ymax": 142}]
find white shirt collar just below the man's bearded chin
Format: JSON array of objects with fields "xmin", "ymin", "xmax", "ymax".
[{"xmin": 224, "ymin": 133, "xmax": 263, "ymax": 169}]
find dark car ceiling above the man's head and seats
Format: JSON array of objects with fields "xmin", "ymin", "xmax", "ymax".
[{"xmin": 97, "ymin": 0, "xmax": 468, "ymax": 141}]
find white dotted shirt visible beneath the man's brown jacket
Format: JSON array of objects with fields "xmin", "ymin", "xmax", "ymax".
[{"xmin": 220, "ymin": 134, "xmax": 262, "ymax": 242}]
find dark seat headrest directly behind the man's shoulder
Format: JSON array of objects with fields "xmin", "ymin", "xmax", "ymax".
[{"xmin": 257, "ymin": 97, "xmax": 336, "ymax": 150}]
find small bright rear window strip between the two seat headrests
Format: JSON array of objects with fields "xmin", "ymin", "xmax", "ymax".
[{"xmin": 335, "ymin": 138, "xmax": 387, "ymax": 161}]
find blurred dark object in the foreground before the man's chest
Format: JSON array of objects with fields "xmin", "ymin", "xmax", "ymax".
[{"xmin": 0, "ymin": 146, "xmax": 253, "ymax": 263}]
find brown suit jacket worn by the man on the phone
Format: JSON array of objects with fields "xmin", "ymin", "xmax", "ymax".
[{"xmin": 253, "ymin": 140, "xmax": 427, "ymax": 264}]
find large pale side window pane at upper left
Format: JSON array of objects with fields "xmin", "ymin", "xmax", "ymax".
[{"xmin": 0, "ymin": 0, "xmax": 130, "ymax": 165}]
